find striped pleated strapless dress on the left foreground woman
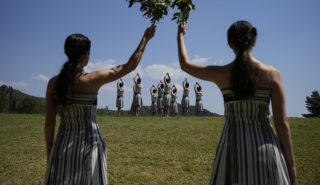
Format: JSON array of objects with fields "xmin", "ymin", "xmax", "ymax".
[{"xmin": 44, "ymin": 92, "xmax": 108, "ymax": 185}]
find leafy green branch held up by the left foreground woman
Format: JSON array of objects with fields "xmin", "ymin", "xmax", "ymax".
[{"xmin": 126, "ymin": 0, "xmax": 172, "ymax": 24}]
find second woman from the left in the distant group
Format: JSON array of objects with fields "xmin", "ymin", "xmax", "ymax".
[{"xmin": 133, "ymin": 73, "xmax": 143, "ymax": 116}]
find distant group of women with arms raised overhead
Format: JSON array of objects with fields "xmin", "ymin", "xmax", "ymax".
[{"xmin": 116, "ymin": 73, "xmax": 203, "ymax": 117}]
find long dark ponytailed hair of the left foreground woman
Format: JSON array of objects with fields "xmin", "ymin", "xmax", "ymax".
[{"xmin": 53, "ymin": 34, "xmax": 91, "ymax": 112}]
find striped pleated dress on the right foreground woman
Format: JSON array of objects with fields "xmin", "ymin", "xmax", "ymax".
[{"xmin": 210, "ymin": 87, "xmax": 290, "ymax": 185}]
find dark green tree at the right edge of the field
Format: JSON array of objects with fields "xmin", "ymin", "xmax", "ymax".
[{"xmin": 302, "ymin": 91, "xmax": 320, "ymax": 117}]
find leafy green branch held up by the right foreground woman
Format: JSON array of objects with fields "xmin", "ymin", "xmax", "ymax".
[{"xmin": 171, "ymin": 0, "xmax": 195, "ymax": 23}]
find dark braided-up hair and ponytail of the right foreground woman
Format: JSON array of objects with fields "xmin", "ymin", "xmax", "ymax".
[{"xmin": 228, "ymin": 21, "xmax": 259, "ymax": 98}]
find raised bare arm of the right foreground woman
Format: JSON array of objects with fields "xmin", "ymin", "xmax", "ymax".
[{"xmin": 177, "ymin": 21, "xmax": 223, "ymax": 83}]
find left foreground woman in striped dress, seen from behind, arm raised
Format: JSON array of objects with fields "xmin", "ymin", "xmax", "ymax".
[{"xmin": 44, "ymin": 25, "xmax": 156, "ymax": 184}]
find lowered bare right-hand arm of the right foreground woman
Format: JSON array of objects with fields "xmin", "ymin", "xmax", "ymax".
[{"xmin": 271, "ymin": 69, "xmax": 296, "ymax": 184}]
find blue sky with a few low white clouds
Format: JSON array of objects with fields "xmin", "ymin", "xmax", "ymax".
[{"xmin": 0, "ymin": 0, "xmax": 320, "ymax": 117}]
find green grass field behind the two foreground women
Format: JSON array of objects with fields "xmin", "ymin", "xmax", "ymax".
[{"xmin": 0, "ymin": 114, "xmax": 320, "ymax": 185}]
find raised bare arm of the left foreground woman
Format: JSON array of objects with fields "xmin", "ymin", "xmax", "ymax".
[{"xmin": 90, "ymin": 25, "xmax": 156, "ymax": 88}]
